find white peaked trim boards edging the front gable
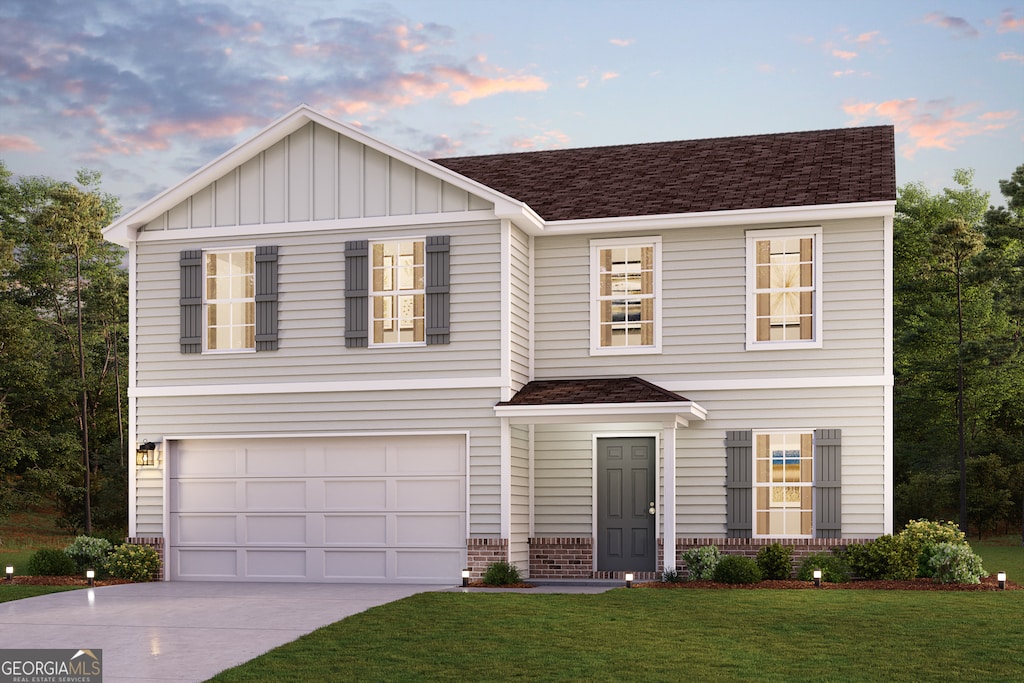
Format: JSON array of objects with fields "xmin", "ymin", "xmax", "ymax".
[{"xmin": 103, "ymin": 104, "xmax": 540, "ymax": 247}]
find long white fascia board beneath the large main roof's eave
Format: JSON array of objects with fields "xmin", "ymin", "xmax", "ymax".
[{"xmin": 544, "ymin": 201, "xmax": 896, "ymax": 234}]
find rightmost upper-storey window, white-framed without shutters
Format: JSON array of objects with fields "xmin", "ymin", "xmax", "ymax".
[{"xmin": 746, "ymin": 228, "xmax": 821, "ymax": 348}]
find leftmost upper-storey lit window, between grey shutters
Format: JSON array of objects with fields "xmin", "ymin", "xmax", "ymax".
[{"xmin": 203, "ymin": 249, "xmax": 256, "ymax": 351}]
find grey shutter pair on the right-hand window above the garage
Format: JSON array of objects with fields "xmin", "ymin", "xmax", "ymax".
[{"xmin": 345, "ymin": 234, "xmax": 451, "ymax": 348}]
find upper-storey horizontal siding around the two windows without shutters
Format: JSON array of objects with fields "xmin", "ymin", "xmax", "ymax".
[{"xmin": 535, "ymin": 218, "xmax": 885, "ymax": 384}]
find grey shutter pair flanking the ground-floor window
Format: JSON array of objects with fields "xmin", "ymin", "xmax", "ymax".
[{"xmin": 725, "ymin": 429, "xmax": 843, "ymax": 539}]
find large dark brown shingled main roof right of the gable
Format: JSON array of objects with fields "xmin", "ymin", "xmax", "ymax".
[{"xmin": 434, "ymin": 126, "xmax": 896, "ymax": 220}]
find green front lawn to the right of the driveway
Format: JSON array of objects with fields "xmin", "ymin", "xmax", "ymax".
[{"xmin": 212, "ymin": 589, "xmax": 1024, "ymax": 682}]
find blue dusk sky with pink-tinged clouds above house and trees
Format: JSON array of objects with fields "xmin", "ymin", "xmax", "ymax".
[{"xmin": 0, "ymin": 0, "xmax": 1024, "ymax": 215}]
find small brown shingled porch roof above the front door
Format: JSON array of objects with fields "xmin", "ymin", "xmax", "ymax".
[{"xmin": 498, "ymin": 377, "xmax": 688, "ymax": 405}]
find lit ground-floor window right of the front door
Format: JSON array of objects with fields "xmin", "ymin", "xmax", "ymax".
[{"xmin": 754, "ymin": 431, "xmax": 814, "ymax": 537}]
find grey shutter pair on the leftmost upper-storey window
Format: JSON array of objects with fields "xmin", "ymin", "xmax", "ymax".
[{"xmin": 178, "ymin": 246, "xmax": 278, "ymax": 353}]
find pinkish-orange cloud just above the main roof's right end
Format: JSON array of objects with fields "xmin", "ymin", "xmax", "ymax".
[{"xmin": 843, "ymin": 97, "xmax": 1020, "ymax": 159}]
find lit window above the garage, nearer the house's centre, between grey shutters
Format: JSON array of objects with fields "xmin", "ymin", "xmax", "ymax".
[{"xmin": 370, "ymin": 240, "xmax": 425, "ymax": 344}]
